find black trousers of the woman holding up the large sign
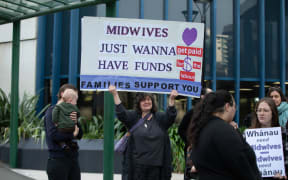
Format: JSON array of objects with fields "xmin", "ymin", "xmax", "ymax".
[{"xmin": 133, "ymin": 164, "xmax": 161, "ymax": 180}]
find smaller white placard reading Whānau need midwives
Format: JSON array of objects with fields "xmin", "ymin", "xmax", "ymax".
[{"xmin": 244, "ymin": 127, "xmax": 285, "ymax": 177}]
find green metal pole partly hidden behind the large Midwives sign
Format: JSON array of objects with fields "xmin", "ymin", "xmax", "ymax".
[{"xmin": 103, "ymin": 2, "xmax": 116, "ymax": 180}]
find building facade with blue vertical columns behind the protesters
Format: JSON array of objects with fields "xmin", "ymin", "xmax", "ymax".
[{"xmin": 0, "ymin": 0, "xmax": 288, "ymax": 125}]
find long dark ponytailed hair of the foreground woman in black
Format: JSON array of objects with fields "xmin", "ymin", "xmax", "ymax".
[{"xmin": 187, "ymin": 90, "xmax": 234, "ymax": 147}]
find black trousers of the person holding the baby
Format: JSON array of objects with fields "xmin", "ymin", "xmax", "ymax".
[{"xmin": 46, "ymin": 158, "xmax": 81, "ymax": 180}]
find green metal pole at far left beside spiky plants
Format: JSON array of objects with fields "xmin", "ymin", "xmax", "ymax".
[{"xmin": 10, "ymin": 20, "xmax": 20, "ymax": 168}]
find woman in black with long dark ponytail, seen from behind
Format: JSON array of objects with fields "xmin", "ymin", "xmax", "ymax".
[{"xmin": 188, "ymin": 90, "xmax": 261, "ymax": 180}]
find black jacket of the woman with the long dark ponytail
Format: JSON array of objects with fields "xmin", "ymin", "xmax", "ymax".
[{"xmin": 192, "ymin": 117, "xmax": 261, "ymax": 180}]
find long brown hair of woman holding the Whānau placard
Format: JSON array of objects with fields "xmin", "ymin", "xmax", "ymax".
[{"xmin": 250, "ymin": 97, "xmax": 280, "ymax": 128}]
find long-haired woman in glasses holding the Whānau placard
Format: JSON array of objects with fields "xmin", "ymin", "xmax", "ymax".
[{"xmin": 251, "ymin": 98, "xmax": 287, "ymax": 180}]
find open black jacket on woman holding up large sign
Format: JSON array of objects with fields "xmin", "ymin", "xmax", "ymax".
[{"xmin": 116, "ymin": 104, "xmax": 177, "ymax": 180}]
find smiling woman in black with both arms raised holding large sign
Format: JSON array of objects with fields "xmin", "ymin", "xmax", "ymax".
[{"xmin": 109, "ymin": 85, "xmax": 178, "ymax": 180}]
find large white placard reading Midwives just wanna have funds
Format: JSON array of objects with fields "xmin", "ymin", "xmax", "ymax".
[{"xmin": 80, "ymin": 17, "xmax": 204, "ymax": 97}]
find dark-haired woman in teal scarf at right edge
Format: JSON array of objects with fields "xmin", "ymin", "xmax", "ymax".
[{"xmin": 267, "ymin": 87, "xmax": 288, "ymax": 129}]
